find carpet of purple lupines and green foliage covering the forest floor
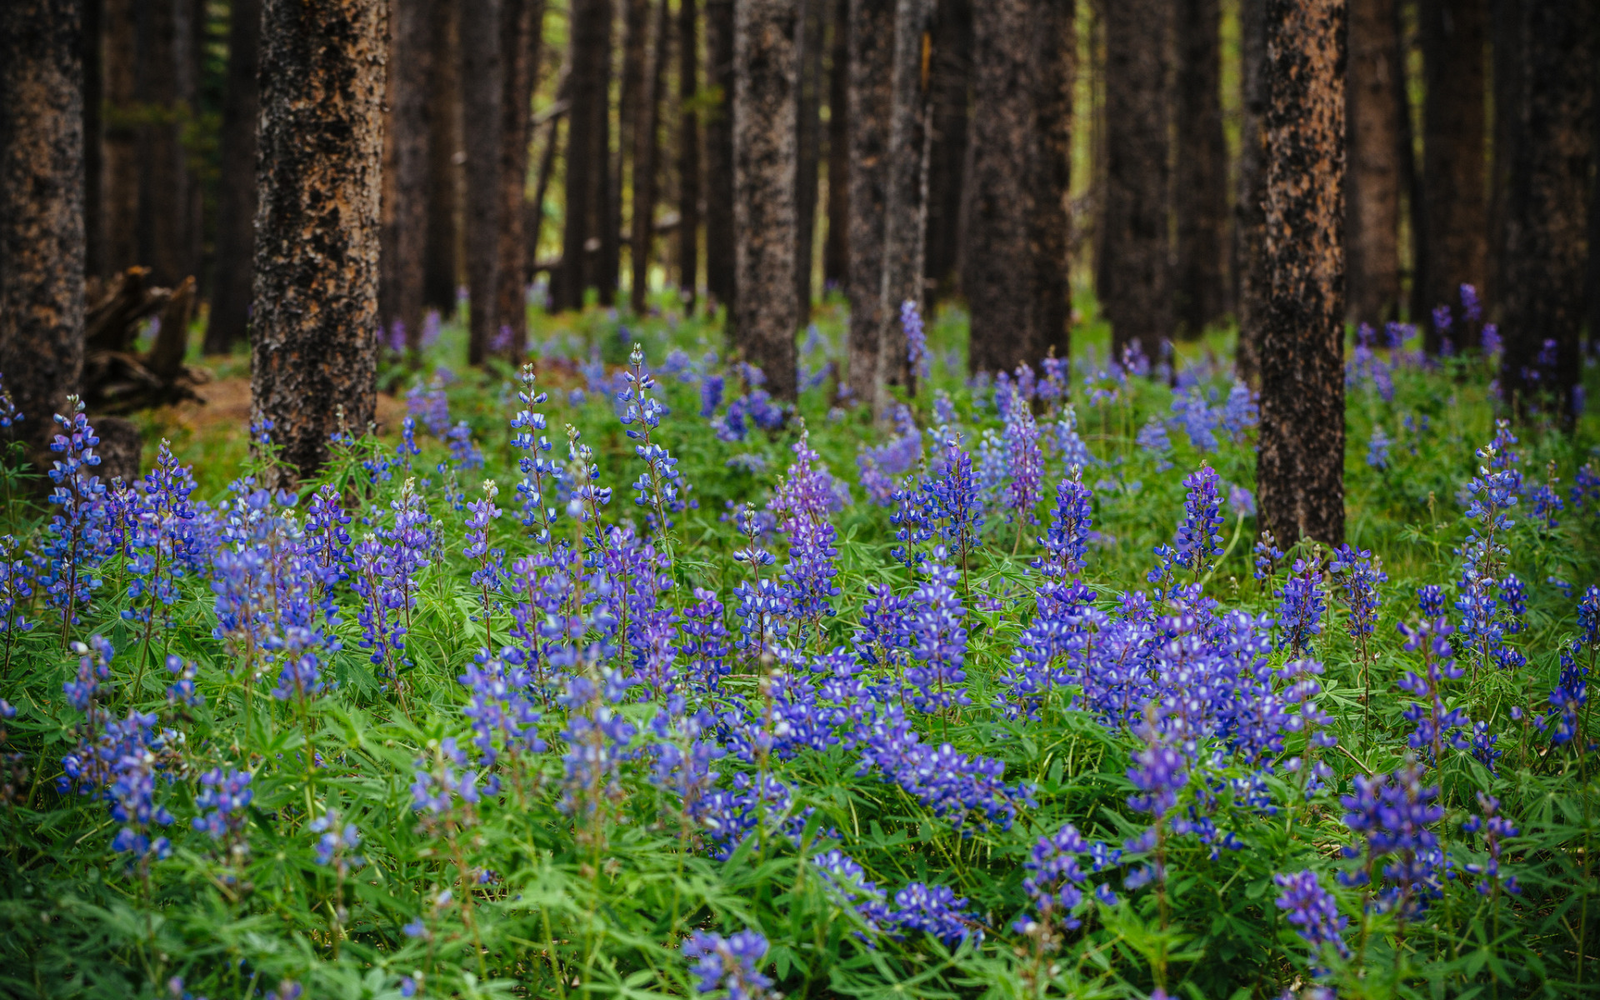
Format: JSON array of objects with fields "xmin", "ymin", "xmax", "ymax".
[{"xmin": 0, "ymin": 291, "xmax": 1600, "ymax": 998}]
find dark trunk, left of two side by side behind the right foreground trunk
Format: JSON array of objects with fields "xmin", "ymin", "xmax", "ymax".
[{"xmin": 1098, "ymin": 0, "xmax": 1173, "ymax": 357}]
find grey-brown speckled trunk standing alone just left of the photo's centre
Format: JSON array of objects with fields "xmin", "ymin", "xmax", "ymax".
[{"xmin": 733, "ymin": 0, "xmax": 800, "ymax": 400}]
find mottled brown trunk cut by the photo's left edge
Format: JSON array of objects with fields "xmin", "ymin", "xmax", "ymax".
[{"xmin": 0, "ymin": 0, "xmax": 85, "ymax": 467}]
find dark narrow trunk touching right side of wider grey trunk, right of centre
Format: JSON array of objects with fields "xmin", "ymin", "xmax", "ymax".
[{"xmin": 1029, "ymin": 0, "xmax": 1075, "ymax": 363}]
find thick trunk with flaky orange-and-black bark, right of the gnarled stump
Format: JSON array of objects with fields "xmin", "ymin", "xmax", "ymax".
[{"xmin": 250, "ymin": 0, "xmax": 387, "ymax": 480}]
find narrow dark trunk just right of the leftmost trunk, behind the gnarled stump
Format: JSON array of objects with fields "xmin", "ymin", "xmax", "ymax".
[{"xmin": 102, "ymin": 0, "xmax": 138, "ymax": 277}]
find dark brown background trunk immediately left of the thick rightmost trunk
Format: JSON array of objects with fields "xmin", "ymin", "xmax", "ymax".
[{"xmin": 1411, "ymin": 0, "xmax": 1488, "ymax": 337}]
